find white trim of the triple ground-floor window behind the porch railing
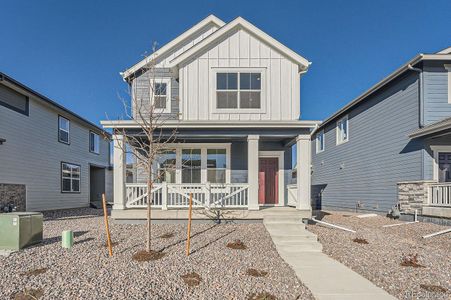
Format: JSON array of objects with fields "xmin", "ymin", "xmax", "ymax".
[{"xmin": 154, "ymin": 143, "xmax": 231, "ymax": 184}]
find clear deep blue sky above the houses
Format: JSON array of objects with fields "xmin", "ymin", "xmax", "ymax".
[{"xmin": 0, "ymin": 0, "xmax": 451, "ymax": 124}]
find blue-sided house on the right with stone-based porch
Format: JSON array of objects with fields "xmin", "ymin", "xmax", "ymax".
[{"xmin": 312, "ymin": 48, "xmax": 451, "ymax": 216}]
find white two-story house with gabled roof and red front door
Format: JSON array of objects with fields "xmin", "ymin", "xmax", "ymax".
[{"xmin": 101, "ymin": 16, "xmax": 318, "ymax": 218}]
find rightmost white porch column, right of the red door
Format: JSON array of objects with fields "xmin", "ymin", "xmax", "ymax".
[{"xmin": 296, "ymin": 134, "xmax": 312, "ymax": 210}]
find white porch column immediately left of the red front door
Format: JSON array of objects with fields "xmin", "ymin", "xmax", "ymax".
[{"xmin": 247, "ymin": 135, "xmax": 260, "ymax": 210}]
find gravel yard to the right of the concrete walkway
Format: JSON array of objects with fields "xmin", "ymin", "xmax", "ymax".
[{"xmin": 307, "ymin": 212, "xmax": 451, "ymax": 299}]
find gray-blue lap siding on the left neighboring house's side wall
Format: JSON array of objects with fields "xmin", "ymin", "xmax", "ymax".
[{"xmin": 0, "ymin": 98, "xmax": 109, "ymax": 211}]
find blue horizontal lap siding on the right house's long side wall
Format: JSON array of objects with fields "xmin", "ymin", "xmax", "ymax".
[{"xmin": 312, "ymin": 72, "xmax": 423, "ymax": 211}]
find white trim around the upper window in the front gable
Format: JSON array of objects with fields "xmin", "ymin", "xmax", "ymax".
[{"xmin": 210, "ymin": 67, "xmax": 268, "ymax": 114}]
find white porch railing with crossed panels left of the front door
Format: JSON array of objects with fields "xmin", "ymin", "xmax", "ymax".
[{"xmin": 125, "ymin": 182, "xmax": 249, "ymax": 209}]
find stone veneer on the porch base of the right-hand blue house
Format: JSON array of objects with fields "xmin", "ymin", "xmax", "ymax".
[{"xmin": 398, "ymin": 180, "xmax": 435, "ymax": 214}]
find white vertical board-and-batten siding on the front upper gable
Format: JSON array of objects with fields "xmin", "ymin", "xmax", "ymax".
[{"xmin": 180, "ymin": 29, "xmax": 300, "ymax": 121}]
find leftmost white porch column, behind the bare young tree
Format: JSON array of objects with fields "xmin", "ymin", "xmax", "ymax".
[{"xmin": 113, "ymin": 135, "xmax": 126, "ymax": 209}]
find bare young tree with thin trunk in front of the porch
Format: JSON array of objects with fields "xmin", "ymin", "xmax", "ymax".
[{"xmin": 109, "ymin": 43, "xmax": 177, "ymax": 253}]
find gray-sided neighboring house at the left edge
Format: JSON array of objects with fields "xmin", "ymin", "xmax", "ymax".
[{"xmin": 0, "ymin": 73, "xmax": 112, "ymax": 211}]
